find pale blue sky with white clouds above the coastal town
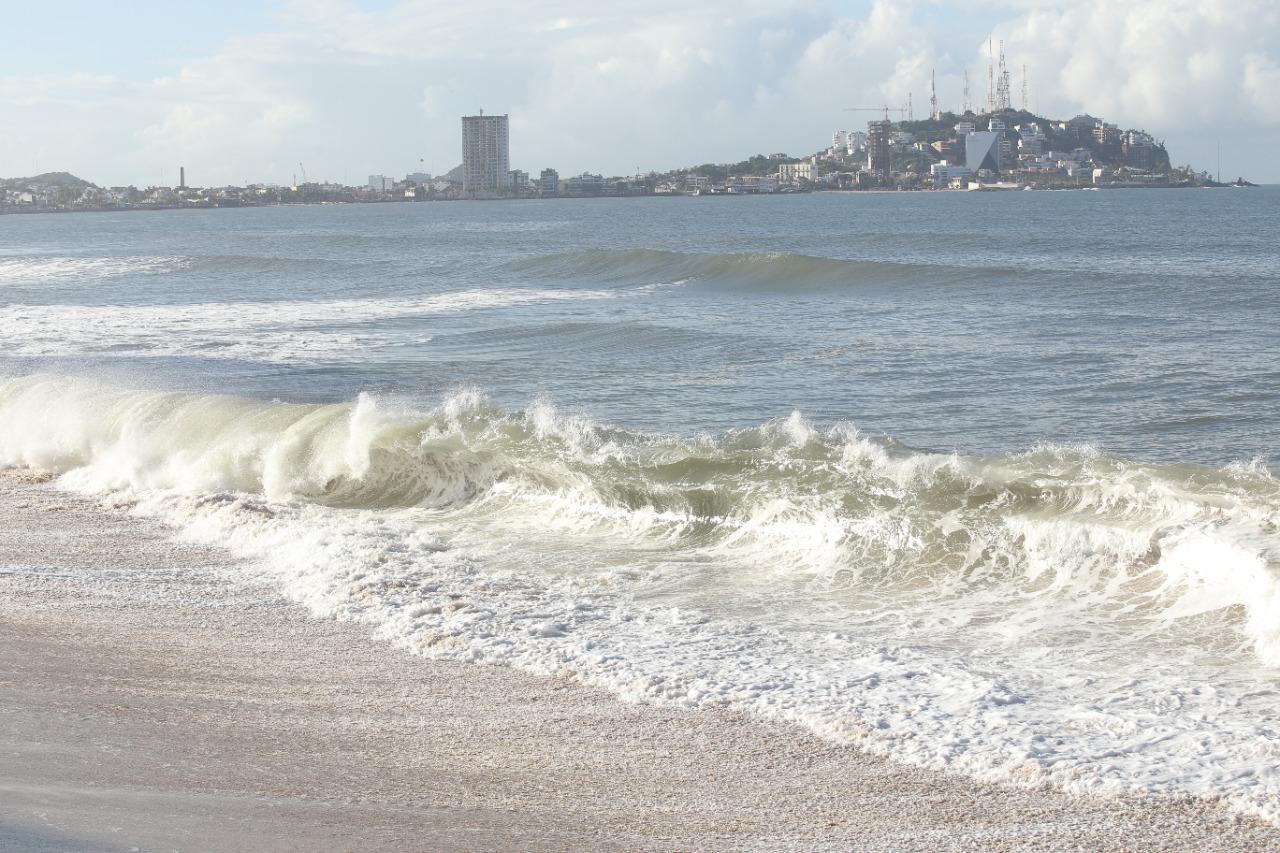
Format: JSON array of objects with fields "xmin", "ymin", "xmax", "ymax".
[{"xmin": 0, "ymin": 0, "xmax": 1280, "ymax": 187}]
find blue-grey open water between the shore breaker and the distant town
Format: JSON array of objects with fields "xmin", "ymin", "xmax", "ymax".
[{"xmin": 0, "ymin": 188, "xmax": 1280, "ymax": 464}]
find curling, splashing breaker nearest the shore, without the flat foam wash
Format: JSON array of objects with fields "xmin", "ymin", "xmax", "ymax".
[{"xmin": 0, "ymin": 375, "xmax": 1280, "ymax": 665}]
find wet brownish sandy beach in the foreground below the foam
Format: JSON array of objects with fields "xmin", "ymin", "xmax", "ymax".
[{"xmin": 0, "ymin": 471, "xmax": 1280, "ymax": 850}]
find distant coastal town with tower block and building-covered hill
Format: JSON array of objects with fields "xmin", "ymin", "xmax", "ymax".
[{"xmin": 0, "ymin": 97, "xmax": 1248, "ymax": 213}]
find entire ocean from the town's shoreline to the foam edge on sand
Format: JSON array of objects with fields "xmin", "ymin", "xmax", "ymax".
[{"xmin": 0, "ymin": 188, "xmax": 1280, "ymax": 821}]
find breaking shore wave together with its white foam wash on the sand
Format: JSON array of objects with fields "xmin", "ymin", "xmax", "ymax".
[{"xmin": 0, "ymin": 377, "xmax": 1280, "ymax": 821}]
